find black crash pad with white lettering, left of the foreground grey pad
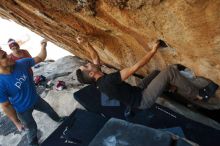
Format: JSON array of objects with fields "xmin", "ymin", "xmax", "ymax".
[{"xmin": 41, "ymin": 109, "xmax": 108, "ymax": 146}]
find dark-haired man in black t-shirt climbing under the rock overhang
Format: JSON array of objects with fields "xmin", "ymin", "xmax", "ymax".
[{"xmin": 76, "ymin": 37, "xmax": 218, "ymax": 109}]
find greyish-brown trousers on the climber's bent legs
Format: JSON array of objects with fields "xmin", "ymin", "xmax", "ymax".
[{"xmin": 139, "ymin": 66, "xmax": 199, "ymax": 109}]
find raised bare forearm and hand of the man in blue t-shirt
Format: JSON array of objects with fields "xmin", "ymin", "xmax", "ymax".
[{"xmin": 34, "ymin": 39, "xmax": 47, "ymax": 64}]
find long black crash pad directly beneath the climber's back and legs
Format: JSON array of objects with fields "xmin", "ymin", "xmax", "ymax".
[{"xmin": 74, "ymin": 85, "xmax": 220, "ymax": 146}]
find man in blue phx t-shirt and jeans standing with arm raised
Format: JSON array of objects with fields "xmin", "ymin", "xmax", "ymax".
[{"xmin": 0, "ymin": 40, "xmax": 63, "ymax": 146}]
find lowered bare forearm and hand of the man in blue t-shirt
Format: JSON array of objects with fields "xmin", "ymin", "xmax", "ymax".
[{"xmin": 0, "ymin": 101, "xmax": 24, "ymax": 131}]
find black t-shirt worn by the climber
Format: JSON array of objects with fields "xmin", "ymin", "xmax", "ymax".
[{"xmin": 97, "ymin": 71, "xmax": 142, "ymax": 107}]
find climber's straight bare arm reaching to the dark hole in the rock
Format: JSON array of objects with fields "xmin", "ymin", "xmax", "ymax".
[{"xmin": 120, "ymin": 41, "xmax": 159, "ymax": 81}]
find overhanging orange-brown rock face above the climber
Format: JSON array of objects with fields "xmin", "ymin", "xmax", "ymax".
[{"xmin": 0, "ymin": 0, "xmax": 220, "ymax": 84}]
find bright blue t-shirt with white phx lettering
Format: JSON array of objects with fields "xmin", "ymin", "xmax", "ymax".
[{"xmin": 0, "ymin": 58, "xmax": 39, "ymax": 113}]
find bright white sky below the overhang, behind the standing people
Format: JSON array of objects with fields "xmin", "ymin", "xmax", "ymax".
[{"xmin": 0, "ymin": 18, "xmax": 72, "ymax": 60}]
